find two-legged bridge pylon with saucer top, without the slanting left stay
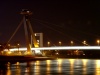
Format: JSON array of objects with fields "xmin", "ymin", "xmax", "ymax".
[{"xmin": 20, "ymin": 9, "xmax": 39, "ymax": 54}]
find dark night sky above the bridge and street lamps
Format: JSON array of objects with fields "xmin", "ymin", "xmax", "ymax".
[{"xmin": 0, "ymin": 0, "xmax": 100, "ymax": 45}]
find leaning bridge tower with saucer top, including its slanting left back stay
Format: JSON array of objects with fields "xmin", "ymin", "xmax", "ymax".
[{"xmin": 7, "ymin": 9, "xmax": 39, "ymax": 55}]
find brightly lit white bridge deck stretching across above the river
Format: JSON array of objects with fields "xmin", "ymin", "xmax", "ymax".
[{"xmin": 10, "ymin": 46, "xmax": 100, "ymax": 51}]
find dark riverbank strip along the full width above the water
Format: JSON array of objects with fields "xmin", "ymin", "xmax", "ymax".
[{"xmin": 0, "ymin": 55, "xmax": 100, "ymax": 63}]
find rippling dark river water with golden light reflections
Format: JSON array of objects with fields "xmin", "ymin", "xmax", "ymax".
[{"xmin": 0, "ymin": 59, "xmax": 100, "ymax": 75}]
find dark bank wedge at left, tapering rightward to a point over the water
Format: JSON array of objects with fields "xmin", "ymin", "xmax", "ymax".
[{"xmin": 0, "ymin": 56, "xmax": 55, "ymax": 63}]
